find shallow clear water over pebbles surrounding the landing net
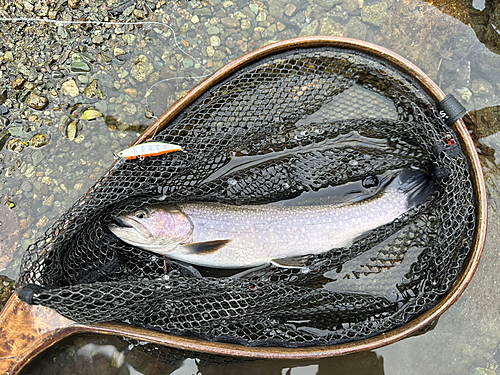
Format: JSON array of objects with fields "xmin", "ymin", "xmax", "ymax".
[{"xmin": 0, "ymin": 0, "xmax": 500, "ymax": 374}]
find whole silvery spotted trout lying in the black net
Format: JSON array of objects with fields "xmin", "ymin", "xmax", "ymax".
[{"xmin": 108, "ymin": 169, "xmax": 436, "ymax": 268}]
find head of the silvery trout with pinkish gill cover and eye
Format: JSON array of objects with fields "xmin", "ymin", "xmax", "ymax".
[{"xmin": 108, "ymin": 204, "xmax": 193, "ymax": 253}]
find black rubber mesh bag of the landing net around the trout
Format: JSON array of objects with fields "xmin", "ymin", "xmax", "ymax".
[{"xmin": 17, "ymin": 48, "xmax": 475, "ymax": 347}]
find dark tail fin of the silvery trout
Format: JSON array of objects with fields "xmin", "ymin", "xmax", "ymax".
[{"xmin": 388, "ymin": 169, "xmax": 437, "ymax": 209}]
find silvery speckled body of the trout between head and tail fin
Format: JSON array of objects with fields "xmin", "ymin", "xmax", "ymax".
[{"xmin": 167, "ymin": 194, "xmax": 407, "ymax": 268}]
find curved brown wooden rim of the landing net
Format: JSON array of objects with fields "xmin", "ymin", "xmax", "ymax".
[{"xmin": 4, "ymin": 36, "xmax": 487, "ymax": 369}]
